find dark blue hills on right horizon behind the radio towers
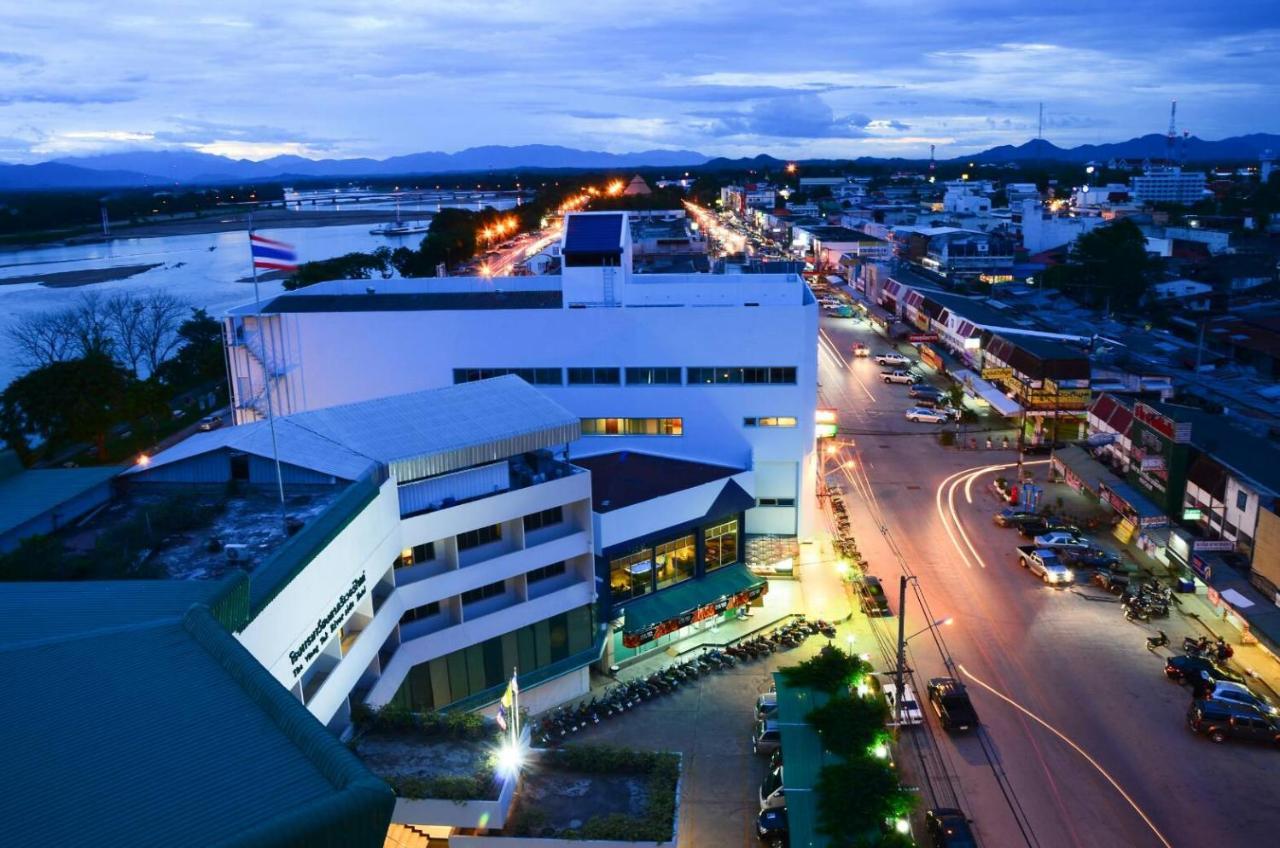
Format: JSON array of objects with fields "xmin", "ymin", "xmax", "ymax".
[{"xmin": 952, "ymin": 132, "xmax": 1280, "ymax": 164}]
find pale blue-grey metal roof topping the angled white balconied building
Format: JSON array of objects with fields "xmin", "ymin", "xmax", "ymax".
[{"xmin": 131, "ymin": 374, "xmax": 581, "ymax": 483}]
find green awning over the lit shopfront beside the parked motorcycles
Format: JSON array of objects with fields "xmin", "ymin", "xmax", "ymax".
[{"xmin": 622, "ymin": 562, "xmax": 769, "ymax": 648}]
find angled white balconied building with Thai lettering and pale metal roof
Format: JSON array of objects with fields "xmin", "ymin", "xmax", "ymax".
[{"xmin": 125, "ymin": 375, "xmax": 603, "ymax": 730}]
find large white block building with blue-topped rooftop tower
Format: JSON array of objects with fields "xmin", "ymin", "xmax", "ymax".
[{"xmin": 225, "ymin": 213, "xmax": 818, "ymax": 534}]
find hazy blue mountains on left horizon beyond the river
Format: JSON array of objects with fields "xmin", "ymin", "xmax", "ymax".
[{"xmin": 44, "ymin": 145, "xmax": 707, "ymax": 188}]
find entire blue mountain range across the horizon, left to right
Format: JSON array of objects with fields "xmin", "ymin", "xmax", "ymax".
[{"xmin": 0, "ymin": 133, "xmax": 1280, "ymax": 191}]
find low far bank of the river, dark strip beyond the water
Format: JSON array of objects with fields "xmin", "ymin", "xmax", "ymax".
[{"xmin": 0, "ymin": 209, "xmax": 430, "ymax": 254}]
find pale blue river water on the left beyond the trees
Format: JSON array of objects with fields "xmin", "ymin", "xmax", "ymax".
[{"xmin": 0, "ymin": 200, "xmax": 515, "ymax": 389}]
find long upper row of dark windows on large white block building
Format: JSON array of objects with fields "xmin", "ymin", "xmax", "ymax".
[{"xmin": 453, "ymin": 365, "xmax": 796, "ymax": 386}]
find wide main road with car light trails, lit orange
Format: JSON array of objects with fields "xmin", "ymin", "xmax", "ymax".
[{"xmin": 818, "ymin": 318, "xmax": 1280, "ymax": 848}]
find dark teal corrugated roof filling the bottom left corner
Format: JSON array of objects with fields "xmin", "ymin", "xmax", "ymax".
[{"xmin": 0, "ymin": 594, "xmax": 394, "ymax": 848}]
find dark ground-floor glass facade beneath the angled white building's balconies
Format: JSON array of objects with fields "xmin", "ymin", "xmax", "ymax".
[{"xmin": 390, "ymin": 606, "xmax": 595, "ymax": 710}]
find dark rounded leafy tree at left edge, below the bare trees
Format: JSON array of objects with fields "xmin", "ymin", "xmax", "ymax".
[{"xmin": 0, "ymin": 354, "xmax": 138, "ymax": 461}]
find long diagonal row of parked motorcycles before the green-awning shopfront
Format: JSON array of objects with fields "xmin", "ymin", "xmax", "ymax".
[{"xmin": 534, "ymin": 616, "xmax": 836, "ymax": 747}]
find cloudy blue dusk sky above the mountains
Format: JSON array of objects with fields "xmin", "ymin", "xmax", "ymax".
[{"xmin": 0, "ymin": 0, "xmax": 1280, "ymax": 163}]
